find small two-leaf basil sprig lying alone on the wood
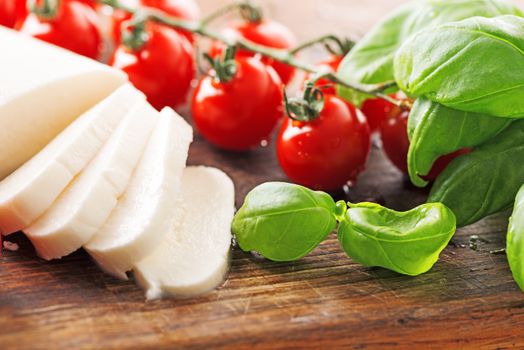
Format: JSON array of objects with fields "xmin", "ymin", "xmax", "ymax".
[{"xmin": 232, "ymin": 182, "xmax": 456, "ymax": 276}]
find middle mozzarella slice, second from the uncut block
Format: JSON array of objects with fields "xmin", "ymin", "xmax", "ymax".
[{"xmin": 23, "ymin": 101, "xmax": 159, "ymax": 260}]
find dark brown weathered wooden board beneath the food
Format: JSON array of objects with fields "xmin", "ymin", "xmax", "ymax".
[{"xmin": 0, "ymin": 1, "xmax": 524, "ymax": 350}]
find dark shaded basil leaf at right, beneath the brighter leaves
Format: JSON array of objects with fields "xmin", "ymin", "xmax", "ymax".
[{"xmin": 428, "ymin": 120, "xmax": 524, "ymax": 226}]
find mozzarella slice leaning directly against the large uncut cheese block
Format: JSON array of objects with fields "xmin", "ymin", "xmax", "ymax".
[{"xmin": 0, "ymin": 84, "xmax": 145, "ymax": 235}]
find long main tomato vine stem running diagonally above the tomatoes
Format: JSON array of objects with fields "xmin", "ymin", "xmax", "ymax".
[{"xmin": 101, "ymin": 0, "xmax": 410, "ymax": 108}]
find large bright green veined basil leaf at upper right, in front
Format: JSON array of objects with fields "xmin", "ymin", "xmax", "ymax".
[{"xmin": 395, "ymin": 16, "xmax": 524, "ymax": 118}]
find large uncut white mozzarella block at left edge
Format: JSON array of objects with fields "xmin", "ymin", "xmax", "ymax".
[{"xmin": 0, "ymin": 26, "xmax": 127, "ymax": 180}]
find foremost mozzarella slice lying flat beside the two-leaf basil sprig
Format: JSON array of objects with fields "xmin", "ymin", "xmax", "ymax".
[{"xmin": 134, "ymin": 167, "xmax": 235, "ymax": 299}]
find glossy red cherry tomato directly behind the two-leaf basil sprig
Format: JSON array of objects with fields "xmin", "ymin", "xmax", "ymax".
[{"xmin": 277, "ymin": 95, "xmax": 371, "ymax": 191}]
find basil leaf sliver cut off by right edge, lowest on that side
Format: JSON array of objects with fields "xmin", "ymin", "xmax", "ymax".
[{"xmin": 506, "ymin": 186, "xmax": 524, "ymax": 291}]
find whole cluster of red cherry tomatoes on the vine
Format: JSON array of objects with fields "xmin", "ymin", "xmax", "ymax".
[{"xmin": 0, "ymin": 0, "xmax": 458, "ymax": 190}]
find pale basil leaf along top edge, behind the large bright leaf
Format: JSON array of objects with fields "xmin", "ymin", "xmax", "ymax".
[{"xmin": 339, "ymin": 0, "xmax": 522, "ymax": 104}]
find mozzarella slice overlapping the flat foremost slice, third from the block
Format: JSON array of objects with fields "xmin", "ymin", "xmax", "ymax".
[{"xmin": 84, "ymin": 108, "xmax": 193, "ymax": 279}]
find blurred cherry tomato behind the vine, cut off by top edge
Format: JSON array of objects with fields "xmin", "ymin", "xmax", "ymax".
[{"xmin": 112, "ymin": 0, "xmax": 200, "ymax": 43}]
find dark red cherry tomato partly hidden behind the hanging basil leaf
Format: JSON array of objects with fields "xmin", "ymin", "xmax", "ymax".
[{"xmin": 380, "ymin": 107, "xmax": 469, "ymax": 181}]
